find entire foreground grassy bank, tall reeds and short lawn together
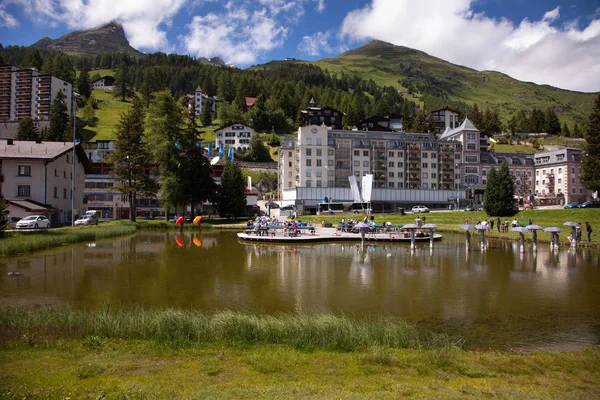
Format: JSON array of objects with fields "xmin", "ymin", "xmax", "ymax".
[{"xmin": 0, "ymin": 307, "xmax": 600, "ymax": 399}]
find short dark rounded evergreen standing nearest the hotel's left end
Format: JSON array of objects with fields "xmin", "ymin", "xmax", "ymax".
[{"xmin": 217, "ymin": 161, "xmax": 246, "ymax": 219}]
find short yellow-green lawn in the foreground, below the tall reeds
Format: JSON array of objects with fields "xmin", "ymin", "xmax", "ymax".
[{"xmin": 0, "ymin": 337, "xmax": 600, "ymax": 400}]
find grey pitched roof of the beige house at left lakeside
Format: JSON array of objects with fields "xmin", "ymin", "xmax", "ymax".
[{"xmin": 0, "ymin": 139, "xmax": 94, "ymax": 174}]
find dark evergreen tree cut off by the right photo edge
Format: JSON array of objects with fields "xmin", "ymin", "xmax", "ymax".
[{"xmin": 581, "ymin": 94, "xmax": 600, "ymax": 195}]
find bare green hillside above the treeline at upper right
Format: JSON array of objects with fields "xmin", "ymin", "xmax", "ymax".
[{"xmin": 314, "ymin": 40, "xmax": 595, "ymax": 126}]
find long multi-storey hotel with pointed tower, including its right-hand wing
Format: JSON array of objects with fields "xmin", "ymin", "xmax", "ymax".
[{"xmin": 278, "ymin": 119, "xmax": 592, "ymax": 212}]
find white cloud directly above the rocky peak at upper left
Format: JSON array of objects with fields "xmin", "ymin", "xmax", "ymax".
[{"xmin": 0, "ymin": 0, "xmax": 187, "ymax": 51}]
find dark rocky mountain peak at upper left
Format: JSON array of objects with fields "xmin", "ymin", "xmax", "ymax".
[{"xmin": 32, "ymin": 21, "xmax": 141, "ymax": 56}]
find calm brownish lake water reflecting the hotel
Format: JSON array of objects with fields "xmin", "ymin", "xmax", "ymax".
[{"xmin": 0, "ymin": 231, "xmax": 600, "ymax": 350}]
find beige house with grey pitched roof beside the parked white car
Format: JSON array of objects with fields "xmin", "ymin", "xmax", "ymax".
[{"xmin": 0, "ymin": 139, "xmax": 93, "ymax": 226}]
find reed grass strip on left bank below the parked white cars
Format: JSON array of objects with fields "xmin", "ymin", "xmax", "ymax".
[{"xmin": 0, "ymin": 222, "xmax": 137, "ymax": 256}]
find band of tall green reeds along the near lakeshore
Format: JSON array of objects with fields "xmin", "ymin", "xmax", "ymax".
[{"xmin": 0, "ymin": 306, "xmax": 460, "ymax": 351}]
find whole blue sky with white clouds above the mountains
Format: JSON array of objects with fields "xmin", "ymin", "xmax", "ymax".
[{"xmin": 0, "ymin": 0, "xmax": 600, "ymax": 92}]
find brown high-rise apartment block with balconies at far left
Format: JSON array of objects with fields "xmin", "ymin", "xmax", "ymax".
[{"xmin": 0, "ymin": 65, "xmax": 73, "ymax": 121}]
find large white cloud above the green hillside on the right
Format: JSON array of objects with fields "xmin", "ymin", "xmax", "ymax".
[{"xmin": 340, "ymin": 0, "xmax": 600, "ymax": 92}]
